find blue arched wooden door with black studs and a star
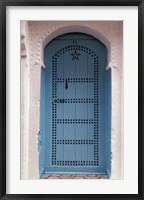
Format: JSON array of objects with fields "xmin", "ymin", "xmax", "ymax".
[{"xmin": 39, "ymin": 33, "xmax": 111, "ymax": 177}]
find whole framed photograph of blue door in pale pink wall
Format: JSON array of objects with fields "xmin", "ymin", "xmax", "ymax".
[{"xmin": 21, "ymin": 21, "xmax": 123, "ymax": 179}]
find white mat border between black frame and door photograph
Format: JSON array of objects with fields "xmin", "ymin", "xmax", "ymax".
[{"xmin": 6, "ymin": 6, "xmax": 138, "ymax": 194}]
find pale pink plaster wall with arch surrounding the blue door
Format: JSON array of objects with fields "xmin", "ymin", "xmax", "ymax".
[{"xmin": 21, "ymin": 21, "xmax": 123, "ymax": 179}]
